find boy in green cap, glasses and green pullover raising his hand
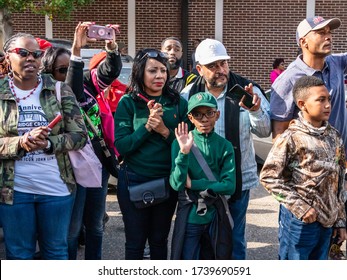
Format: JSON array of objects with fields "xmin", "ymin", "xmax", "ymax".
[{"xmin": 170, "ymin": 92, "xmax": 236, "ymax": 260}]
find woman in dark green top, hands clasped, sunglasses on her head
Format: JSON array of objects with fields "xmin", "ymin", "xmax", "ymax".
[{"xmin": 115, "ymin": 49, "xmax": 187, "ymax": 260}]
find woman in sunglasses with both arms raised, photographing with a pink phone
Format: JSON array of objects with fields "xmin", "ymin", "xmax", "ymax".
[{"xmin": 42, "ymin": 22, "xmax": 122, "ymax": 260}]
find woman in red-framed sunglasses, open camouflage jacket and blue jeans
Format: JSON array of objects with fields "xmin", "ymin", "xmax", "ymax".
[{"xmin": 0, "ymin": 33, "xmax": 87, "ymax": 260}]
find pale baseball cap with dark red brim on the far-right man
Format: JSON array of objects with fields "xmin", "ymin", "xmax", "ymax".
[{"xmin": 296, "ymin": 16, "xmax": 341, "ymax": 46}]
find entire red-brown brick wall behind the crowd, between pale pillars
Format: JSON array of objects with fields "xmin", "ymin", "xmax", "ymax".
[{"xmin": 9, "ymin": 0, "xmax": 347, "ymax": 89}]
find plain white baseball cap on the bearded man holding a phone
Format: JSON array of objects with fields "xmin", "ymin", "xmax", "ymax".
[{"xmin": 195, "ymin": 39, "xmax": 230, "ymax": 65}]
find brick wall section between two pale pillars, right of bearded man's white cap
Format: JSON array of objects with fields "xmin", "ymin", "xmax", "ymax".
[{"xmin": 223, "ymin": 0, "xmax": 306, "ymax": 90}]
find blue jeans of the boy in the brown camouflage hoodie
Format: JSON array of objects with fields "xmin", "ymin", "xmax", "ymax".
[{"xmin": 278, "ymin": 205, "xmax": 332, "ymax": 260}]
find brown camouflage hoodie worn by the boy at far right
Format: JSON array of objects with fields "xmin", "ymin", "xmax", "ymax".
[{"xmin": 260, "ymin": 112, "xmax": 346, "ymax": 227}]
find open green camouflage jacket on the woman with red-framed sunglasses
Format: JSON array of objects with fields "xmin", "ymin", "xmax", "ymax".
[{"xmin": 0, "ymin": 75, "xmax": 87, "ymax": 204}]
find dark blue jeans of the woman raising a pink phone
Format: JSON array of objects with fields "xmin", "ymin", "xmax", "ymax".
[{"xmin": 68, "ymin": 168, "xmax": 110, "ymax": 260}]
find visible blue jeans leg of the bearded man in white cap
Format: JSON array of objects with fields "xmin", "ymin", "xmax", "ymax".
[{"xmin": 229, "ymin": 190, "xmax": 250, "ymax": 260}]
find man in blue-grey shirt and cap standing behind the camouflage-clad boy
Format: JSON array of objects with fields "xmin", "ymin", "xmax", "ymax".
[{"xmin": 270, "ymin": 16, "xmax": 347, "ymax": 258}]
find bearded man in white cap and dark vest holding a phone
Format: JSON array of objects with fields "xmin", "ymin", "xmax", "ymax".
[{"xmin": 181, "ymin": 39, "xmax": 271, "ymax": 260}]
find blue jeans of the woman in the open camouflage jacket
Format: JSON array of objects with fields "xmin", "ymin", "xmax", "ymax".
[{"xmin": 0, "ymin": 191, "xmax": 75, "ymax": 260}]
